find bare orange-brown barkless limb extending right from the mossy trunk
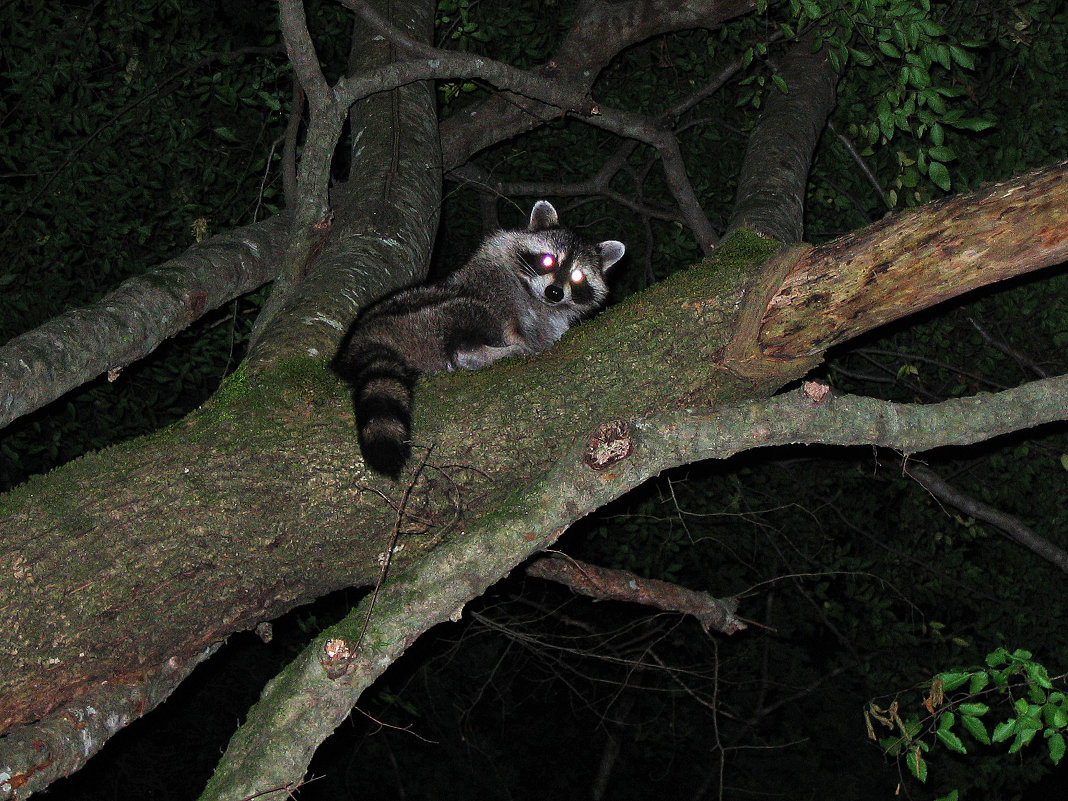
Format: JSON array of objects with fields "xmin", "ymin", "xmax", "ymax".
[{"xmin": 760, "ymin": 161, "xmax": 1068, "ymax": 359}]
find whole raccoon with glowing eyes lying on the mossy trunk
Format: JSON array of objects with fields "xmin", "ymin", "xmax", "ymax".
[{"xmin": 332, "ymin": 201, "xmax": 625, "ymax": 478}]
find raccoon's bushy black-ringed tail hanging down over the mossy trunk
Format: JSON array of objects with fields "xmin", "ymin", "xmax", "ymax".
[{"xmin": 334, "ymin": 343, "xmax": 419, "ymax": 478}]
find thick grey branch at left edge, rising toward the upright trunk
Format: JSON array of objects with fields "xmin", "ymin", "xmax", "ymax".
[{"xmin": 0, "ymin": 215, "xmax": 288, "ymax": 427}]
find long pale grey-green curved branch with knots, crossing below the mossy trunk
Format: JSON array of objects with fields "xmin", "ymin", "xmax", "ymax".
[{"xmin": 194, "ymin": 376, "xmax": 1068, "ymax": 801}]
